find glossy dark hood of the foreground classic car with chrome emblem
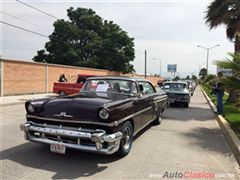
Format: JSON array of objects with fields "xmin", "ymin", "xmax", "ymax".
[{"xmin": 31, "ymin": 94, "xmax": 130, "ymax": 121}]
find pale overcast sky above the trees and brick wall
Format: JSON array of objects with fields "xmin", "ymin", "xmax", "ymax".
[{"xmin": 0, "ymin": 0, "xmax": 234, "ymax": 78}]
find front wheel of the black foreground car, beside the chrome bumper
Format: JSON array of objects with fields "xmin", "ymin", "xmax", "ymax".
[{"xmin": 117, "ymin": 121, "xmax": 133, "ymax": 157}]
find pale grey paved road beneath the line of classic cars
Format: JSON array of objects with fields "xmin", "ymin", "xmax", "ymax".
[{"xmin": 0, "ymin": 89, "xmax": 239, "ymax": 180}]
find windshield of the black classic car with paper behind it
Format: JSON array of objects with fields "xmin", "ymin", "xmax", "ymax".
[{"xmin": 81, "ymin": 79, "xmax": 138, "ymax": 95}]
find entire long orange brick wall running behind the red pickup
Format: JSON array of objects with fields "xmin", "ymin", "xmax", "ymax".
[{"xmin": 0, "ymin": 60, "xmax": 163, "ymax": 96}]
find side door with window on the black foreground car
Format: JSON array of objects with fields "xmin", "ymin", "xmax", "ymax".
[{"xmin": 139, "ymin": 81, "xmax": 155, "ymax": 126}]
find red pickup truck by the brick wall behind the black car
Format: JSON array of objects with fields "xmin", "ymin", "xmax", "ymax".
[{"xmin": 53, "ymin": 74, "xmax": 95, "ymax": 96}]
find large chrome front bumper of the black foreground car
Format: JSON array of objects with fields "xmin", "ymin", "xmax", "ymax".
[{"xmin": 20, "ymin": 122, "xmax": 122, "ymax": 154}]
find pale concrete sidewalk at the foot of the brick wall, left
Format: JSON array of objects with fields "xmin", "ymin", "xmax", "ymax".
[{"xmin": 0, "ymin": 93, "xmax": 58, "ymax": 106}]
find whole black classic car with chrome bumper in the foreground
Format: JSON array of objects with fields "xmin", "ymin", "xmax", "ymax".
[{"xmin": 20, "ymin": 76, "xmax": 167, "ymax": 156}]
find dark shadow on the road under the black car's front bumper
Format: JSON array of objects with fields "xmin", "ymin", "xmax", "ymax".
[{"xmin": 0, "ymin": 143, "xmax": 119, "ymax": 179}]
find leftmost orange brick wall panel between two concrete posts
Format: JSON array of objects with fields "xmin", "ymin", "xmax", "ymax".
[{"xmin": 3, "ymin": 61, "xmax": 45, "ymax": 95}]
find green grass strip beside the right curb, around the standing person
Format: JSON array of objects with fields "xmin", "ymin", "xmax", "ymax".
[{"xmin": 201, "ymin": 85, "xmax": 240, "ymax": 133}]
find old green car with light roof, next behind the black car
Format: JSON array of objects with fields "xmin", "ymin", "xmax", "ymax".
[{"xmin": 163, "ymin": 81, "xmax": 190, "ymax": 107}]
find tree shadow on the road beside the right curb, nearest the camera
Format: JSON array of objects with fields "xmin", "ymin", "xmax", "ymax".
[{"xmin": 181, "ymin": 127, "xmax": 232, "ymax": 156}]
